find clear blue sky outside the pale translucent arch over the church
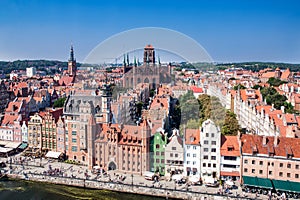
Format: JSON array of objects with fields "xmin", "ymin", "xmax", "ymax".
[{"xmin": 0, "ymin": 0, "xmax": 300, "ymax": 63}]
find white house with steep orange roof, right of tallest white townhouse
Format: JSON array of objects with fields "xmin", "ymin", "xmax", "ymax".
[{"xmin": 220, "ymin": 135, "xmax": 241, "ymax": 180}]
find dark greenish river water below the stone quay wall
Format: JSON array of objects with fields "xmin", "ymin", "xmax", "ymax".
[{"xmin": 0, "ymin": 180, "xmax": 163, "ymax": 200}]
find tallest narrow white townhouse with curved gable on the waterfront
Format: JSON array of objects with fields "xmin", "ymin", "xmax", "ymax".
[{"xmin": 200, "ymin": 119, "xmax": 221, "ymax": 183}]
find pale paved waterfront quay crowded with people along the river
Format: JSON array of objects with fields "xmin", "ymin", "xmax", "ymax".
[{"xmin": 2, "ymin": 157, "xmax": 266, "ymax": 199}]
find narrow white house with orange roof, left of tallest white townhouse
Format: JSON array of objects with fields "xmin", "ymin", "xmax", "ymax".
[{"xmin": 184, "ymin": 129, "xmax": 201, "ymax": 181}]
